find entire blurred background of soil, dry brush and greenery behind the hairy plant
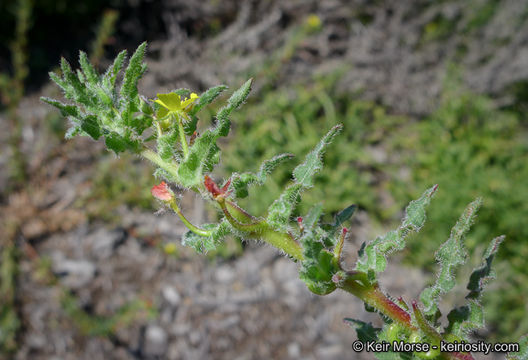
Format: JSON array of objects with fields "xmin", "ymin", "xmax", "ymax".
[{"xmin": 0, "ymin": 0, "xmax": 528, "ymax": 359}]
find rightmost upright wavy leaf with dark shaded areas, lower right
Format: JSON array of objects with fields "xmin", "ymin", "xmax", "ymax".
[{"xmin": 447, "ymin": 236, "xmax": 504, "ymax": 340}]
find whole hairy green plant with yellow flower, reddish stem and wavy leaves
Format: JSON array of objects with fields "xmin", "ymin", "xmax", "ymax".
[{"xmin": 42, "ymin": 43, "xmax": 528, "ymax": 359}]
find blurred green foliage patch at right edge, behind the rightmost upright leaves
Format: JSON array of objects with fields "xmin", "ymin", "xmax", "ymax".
[{"xmin": 388, "ymin": 80, "xmax": 528, "ymax": 336}]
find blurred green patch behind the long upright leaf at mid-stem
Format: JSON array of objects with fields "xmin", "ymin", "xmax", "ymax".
[{"xmin": 223, "ymin": 72, "xmax": 407, "ymax": 218}]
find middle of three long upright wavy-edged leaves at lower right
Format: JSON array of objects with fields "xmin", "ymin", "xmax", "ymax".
[{"xmin": 420, "ymin": 198, "xmax": 482, "ymax": 317}]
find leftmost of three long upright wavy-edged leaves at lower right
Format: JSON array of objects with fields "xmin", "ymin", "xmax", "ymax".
[{"xmin": 356, "ymin": 185, "xmax": 438, "ymax": 280}]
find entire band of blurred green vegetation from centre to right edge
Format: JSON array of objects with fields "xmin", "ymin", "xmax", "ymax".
[{"xmin": 223, "ymin": 70, "xmax": 528, "ymax": 341}]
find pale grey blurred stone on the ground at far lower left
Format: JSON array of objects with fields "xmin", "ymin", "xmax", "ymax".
[{"xmin": 53, "ymin": 259, "xmax": 96, "ymax": 289}]
